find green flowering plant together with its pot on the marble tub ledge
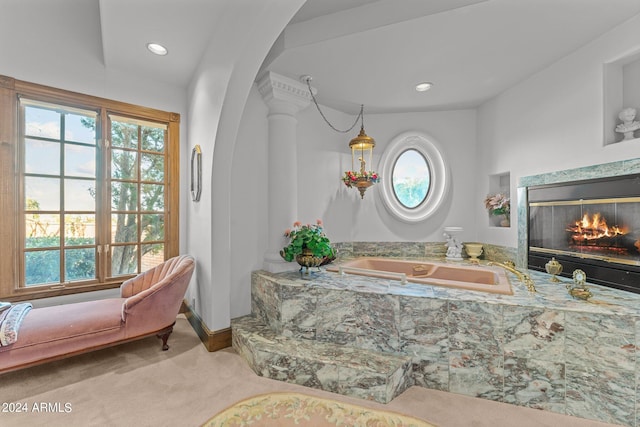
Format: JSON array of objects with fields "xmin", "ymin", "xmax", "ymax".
[{"xmin": 280, "ymin": 220, "xmax": 335, "ymax": 273}]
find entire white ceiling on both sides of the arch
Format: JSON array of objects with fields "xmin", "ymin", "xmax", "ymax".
[{"xmin": 0, "ymin": 0, "xmax": 640, "ymax": 114}]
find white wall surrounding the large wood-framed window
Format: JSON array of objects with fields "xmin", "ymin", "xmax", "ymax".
[{"xmin": 0, "ymin": 2, "xmax": 189, "ymax": 306}]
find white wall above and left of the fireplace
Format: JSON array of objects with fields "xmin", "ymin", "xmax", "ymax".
[{"xmin": 475, "ymin": 15, "xmax": 640, "ymax": 247}]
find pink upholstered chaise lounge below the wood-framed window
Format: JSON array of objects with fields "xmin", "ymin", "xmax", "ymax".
[{"xmin": 0, "ymin": 255, "xmax": 195, "ymax": 373}]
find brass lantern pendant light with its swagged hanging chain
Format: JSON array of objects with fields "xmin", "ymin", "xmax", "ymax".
[{"xmin": 300, "ymin": 75, "xmax": 380, "ymax": 199}]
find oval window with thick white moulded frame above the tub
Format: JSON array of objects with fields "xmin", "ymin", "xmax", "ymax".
[{"xmin": 380, "ymin": 132, "xmax": 449, "ymax": 222}]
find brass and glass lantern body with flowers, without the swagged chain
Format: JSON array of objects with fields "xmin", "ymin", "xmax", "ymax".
[{"xmin": 342, "ymin": 122, "xmax": 380, "ymax": 199}]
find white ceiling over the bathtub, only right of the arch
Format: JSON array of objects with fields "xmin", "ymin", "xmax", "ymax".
[{"xmin": 264, "ymin": 0, "xmax": 640, "ymax": 114}]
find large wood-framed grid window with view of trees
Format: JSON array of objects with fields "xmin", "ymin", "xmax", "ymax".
[{"xmin": 0, "ymin": 76, "xmax": 179, "ymax": 299}]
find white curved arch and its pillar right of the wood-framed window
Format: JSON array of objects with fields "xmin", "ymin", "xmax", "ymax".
[{"xmin": 187, "ymin": 0, "xmax": 304, "ymax": 331}]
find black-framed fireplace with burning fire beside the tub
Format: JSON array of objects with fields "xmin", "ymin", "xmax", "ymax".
[{"xmin": 527, "ymin": 174, "xmax": 640, "ymax": 293}]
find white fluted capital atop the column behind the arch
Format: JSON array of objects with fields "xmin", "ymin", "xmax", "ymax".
[{"xmin": 258, "ymin": 71, "xmax": 313, "ymax": 116}]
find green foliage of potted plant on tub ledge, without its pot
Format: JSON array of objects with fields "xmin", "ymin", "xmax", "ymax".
[{"xmin": 280, "ymin": 220, "xmax": 335, "ymax": 262}]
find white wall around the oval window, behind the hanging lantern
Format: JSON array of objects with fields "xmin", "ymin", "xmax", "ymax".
[{"xmin": 298, "ymin": 105, "xmax": 476, "ymax": 246}]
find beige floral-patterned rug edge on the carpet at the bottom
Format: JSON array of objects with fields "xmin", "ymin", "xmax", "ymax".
[{"xmin": 202, "ymin": 393, "xmax": 435, "ymax": 427}]
